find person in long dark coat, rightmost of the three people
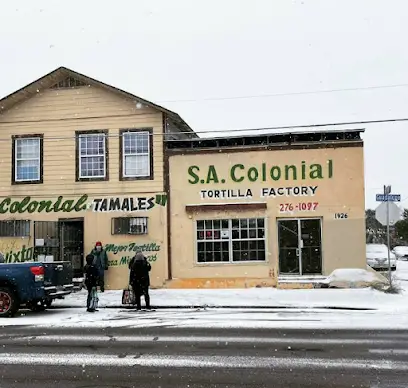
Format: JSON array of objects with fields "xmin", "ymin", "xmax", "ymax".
[{"xmin": 129, "ymin": 251, "xmax": 152, "ymax": 310}]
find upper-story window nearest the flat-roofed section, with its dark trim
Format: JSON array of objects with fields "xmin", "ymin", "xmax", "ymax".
[{"xmin": 120, "ymin": 129, "xmax": 153, "ymax": 180}]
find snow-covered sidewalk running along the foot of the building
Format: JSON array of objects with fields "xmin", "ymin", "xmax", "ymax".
[{"xmin": 53, "ymin": 288, "xmax": 408, "ymax": 311}]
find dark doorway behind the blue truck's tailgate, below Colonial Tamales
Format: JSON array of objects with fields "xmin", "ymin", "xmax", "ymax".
[{"xmin": 60, "ymin": 219, "xmax": 84, "ymax": 277}]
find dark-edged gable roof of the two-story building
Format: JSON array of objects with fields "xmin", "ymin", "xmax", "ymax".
[{"xmin": 0, "ymin": 66, "xmax": 197, "ymax": 136}]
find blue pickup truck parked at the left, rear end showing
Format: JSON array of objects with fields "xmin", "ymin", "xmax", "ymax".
[{"xmin": 0, "ymin": 261, "xmax": 74, "ymax": 318}]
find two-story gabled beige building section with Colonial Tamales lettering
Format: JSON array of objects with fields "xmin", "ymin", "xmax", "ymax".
[{"xmin": 0, "ymin": 67, "xmax": 196, "ymax": 289}]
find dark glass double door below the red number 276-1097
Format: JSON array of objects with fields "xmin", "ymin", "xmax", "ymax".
[{"xmin": 278, "ymin": 218, "xmax": 322, "ymax": 275}]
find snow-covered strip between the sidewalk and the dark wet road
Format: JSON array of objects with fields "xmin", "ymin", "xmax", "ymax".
[{"xmin": 0, "ymin": 308, "xmax": 408, "ymax": 330}]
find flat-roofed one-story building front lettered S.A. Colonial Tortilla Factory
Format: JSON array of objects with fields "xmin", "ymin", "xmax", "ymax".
[{"xmin": 168, "ymin": 131, "xmax": 366, "ymax": 288}]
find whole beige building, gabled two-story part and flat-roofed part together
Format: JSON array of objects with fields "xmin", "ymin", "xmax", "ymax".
[{"xmin": 0, "ymin": 68, "xmax": 365, "ymax": 289}]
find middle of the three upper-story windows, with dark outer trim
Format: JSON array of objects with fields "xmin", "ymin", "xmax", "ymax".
[{"xmin": 76, "ymin": 131, "xmax": 108, "ymax": 181}]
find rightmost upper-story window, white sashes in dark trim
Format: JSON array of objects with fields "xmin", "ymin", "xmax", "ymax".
[{"xmin": 122, "ymin": 131, "xmax": 152, "ymax": 178}]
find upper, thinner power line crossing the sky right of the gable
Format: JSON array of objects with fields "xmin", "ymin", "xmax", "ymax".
[{"xmin": 157, "ymin": 84, "xmax": 408, "ymax": 104}]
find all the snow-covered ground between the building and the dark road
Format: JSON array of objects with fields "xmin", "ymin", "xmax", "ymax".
[{"xmin": 0, "ymin": 261, "xmax": 408, "ymax": 329}]
